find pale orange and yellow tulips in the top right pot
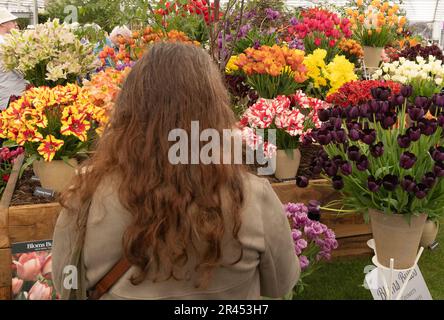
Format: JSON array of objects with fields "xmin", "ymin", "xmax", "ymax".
[{"xmin": 347, "ymin": 0, "xmax": 407, "ymax": 48}]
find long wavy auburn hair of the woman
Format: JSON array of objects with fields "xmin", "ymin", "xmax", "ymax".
[{"xmin": 60, "ymin": 43, "xmax": 244, "ymax": 287}]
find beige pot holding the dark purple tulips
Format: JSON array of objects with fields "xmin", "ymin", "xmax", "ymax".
[{"xmin": 369, "ymin": 209, "xmax": 427, "ymax": 269}]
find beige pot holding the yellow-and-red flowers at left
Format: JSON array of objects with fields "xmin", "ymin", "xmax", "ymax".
[{"xmin": 33, "ymin": 159, "xmax": 78, "ymax": 192}]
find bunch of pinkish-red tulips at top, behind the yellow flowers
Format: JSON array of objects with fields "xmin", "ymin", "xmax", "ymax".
[{"xmin": 294, "ymin": 7, "xmax": 352, "ymax": 61}]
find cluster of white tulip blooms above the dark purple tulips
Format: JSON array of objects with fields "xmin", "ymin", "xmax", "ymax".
[{"xmin": 372, "ymin": 56, "xmax": 444, "ymax": 86}]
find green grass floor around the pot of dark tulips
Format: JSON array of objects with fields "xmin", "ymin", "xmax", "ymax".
[{"xmin": 295, "ymin": 219, "xmax": 444, "ymax": 300}]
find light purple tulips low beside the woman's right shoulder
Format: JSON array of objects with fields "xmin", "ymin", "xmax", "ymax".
[{"xmin": 284, "ymin": 203, "xmax": 338, "ymax": 296}]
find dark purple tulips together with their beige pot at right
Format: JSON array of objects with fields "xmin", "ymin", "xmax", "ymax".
[{"xmin": 297, "ymin": 86, "xmax": 444, "ymax": 269}]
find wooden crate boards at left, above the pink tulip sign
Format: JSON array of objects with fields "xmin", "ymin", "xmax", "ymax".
[{"xmin": 0, "ymin": 156, "xmax": 60, "ymax": 300}]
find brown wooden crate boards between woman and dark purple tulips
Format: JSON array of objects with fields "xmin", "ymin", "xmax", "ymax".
[{"xmin": 272, "ymin": 180, "xmax": 373, "ymax": 257}]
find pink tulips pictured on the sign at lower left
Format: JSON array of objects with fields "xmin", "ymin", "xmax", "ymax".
[{"xmin": 11, "ymin": 251, "xmax": 60, "ymax": 300}]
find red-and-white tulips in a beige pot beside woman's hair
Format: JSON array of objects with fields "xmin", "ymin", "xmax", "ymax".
[{"xmin": 240, "ymin": 91, "xmax": 327, "ymax": 179}]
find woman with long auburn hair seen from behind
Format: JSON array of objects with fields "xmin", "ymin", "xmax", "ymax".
[{"xmin": 53, "ymin": 43, "xmax": 300, "ymax": 299}]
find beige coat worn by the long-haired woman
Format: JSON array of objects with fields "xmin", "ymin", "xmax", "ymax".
[{"xmin": 52, "ymin": 175, "xmax": 300, "ymax": 299}]
